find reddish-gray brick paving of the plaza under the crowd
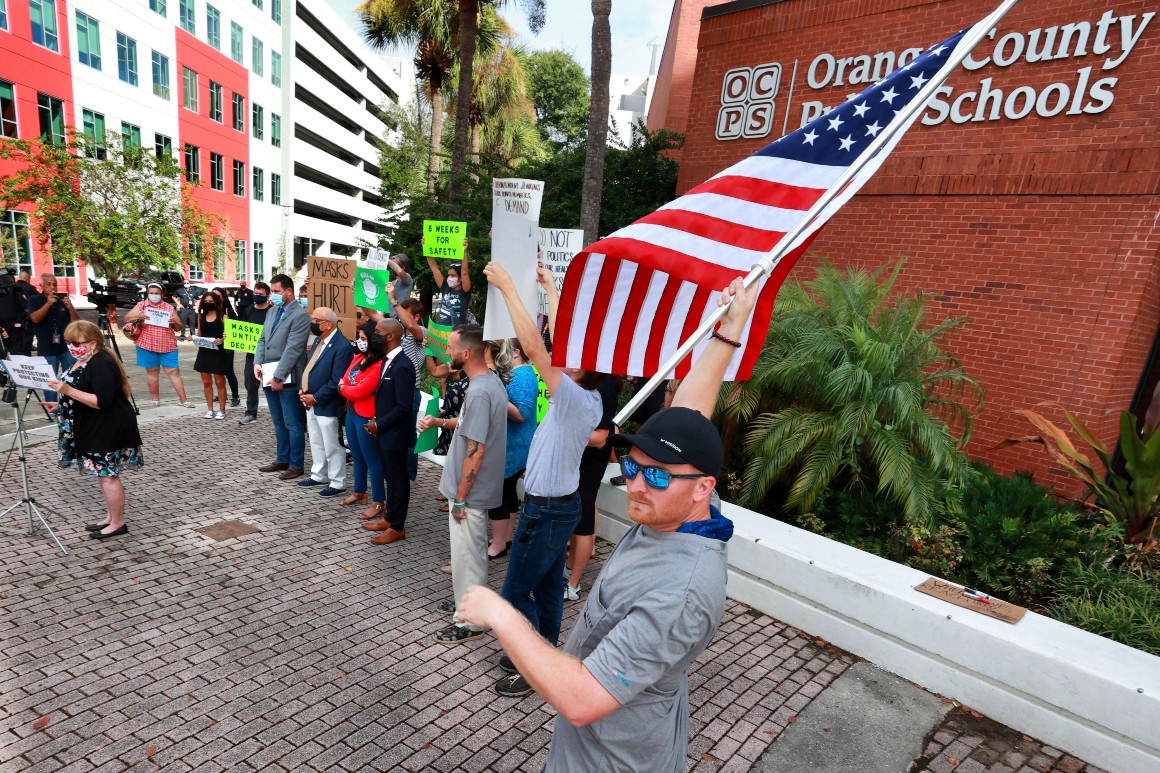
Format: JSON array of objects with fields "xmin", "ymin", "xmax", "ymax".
[{"xmin": 0, "ymin": 406, "xmax": 1096, "ymax": 773}]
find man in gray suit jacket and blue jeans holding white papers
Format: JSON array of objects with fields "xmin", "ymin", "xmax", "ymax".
[{"xmin": 254, "ymin": 274, "xmax": 310, "ymax": 481}]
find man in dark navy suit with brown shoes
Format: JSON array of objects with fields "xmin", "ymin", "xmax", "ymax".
[{"xmin": 363, "ymin": 317, "xmax": 418, "ymax": 544}]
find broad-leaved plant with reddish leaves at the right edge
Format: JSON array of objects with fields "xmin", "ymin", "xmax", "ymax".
[{"xmin": 998, "ymin": 403, "xmax": 1160, "ymax": 552}]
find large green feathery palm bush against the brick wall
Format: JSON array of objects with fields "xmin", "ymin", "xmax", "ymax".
[{"xmin": 722, "ymin": 259, "xmax": 983, "ymax": 534}]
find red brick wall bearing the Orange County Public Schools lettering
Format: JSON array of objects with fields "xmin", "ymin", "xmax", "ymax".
[{"xmin": 679, "ymin": 0, "xmax": 1160, "ymax": 492}]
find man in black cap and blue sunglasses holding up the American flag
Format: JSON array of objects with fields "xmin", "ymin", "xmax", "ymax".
[{"xmin": 459, "ymin": 280, "xmax": 756, "ymax": 773}]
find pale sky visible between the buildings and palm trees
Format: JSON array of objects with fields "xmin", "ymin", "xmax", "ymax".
[{"xmin": 326, "ymin": 0, "xmax": 673, "ymax": 75}]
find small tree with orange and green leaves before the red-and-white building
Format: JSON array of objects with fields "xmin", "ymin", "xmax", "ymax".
[{"xmin": 0, "ymin": 132, "xmax": 223, "ymax": 281}]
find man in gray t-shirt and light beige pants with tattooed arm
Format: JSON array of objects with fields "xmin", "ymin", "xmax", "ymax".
[{"xmin": 419, "ymin": 325, "xmax": 507, "ymax": 644}]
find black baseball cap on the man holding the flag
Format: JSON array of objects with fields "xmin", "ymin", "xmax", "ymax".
[{"xmin": 609, "ymin": 407, "xmax": 725, "ymax": 478}]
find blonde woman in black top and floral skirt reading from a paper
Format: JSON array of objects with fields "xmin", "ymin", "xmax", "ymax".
[{"xmin": 44, "ymin": 319, "xmax": 144, "ymax": 540}]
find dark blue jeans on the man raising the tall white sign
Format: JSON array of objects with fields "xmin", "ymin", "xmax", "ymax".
[{"xmin": 500, "ymin": 496, "xmax": 580, "ymax": 646}]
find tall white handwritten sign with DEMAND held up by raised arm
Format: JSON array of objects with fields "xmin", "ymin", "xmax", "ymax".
[{"xmin": 484, "ymin": 178, "xmax": 544, "ymax": 341}]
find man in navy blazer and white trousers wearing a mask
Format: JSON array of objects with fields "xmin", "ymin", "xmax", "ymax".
[{"xmin": 298, "ymin": 306, "xmax": 355, "ymax": 497}]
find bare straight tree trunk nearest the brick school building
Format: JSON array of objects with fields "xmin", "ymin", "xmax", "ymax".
[{"xmin": 580, "ymin": 0, "xmax": 612, "ymax": 245}]
